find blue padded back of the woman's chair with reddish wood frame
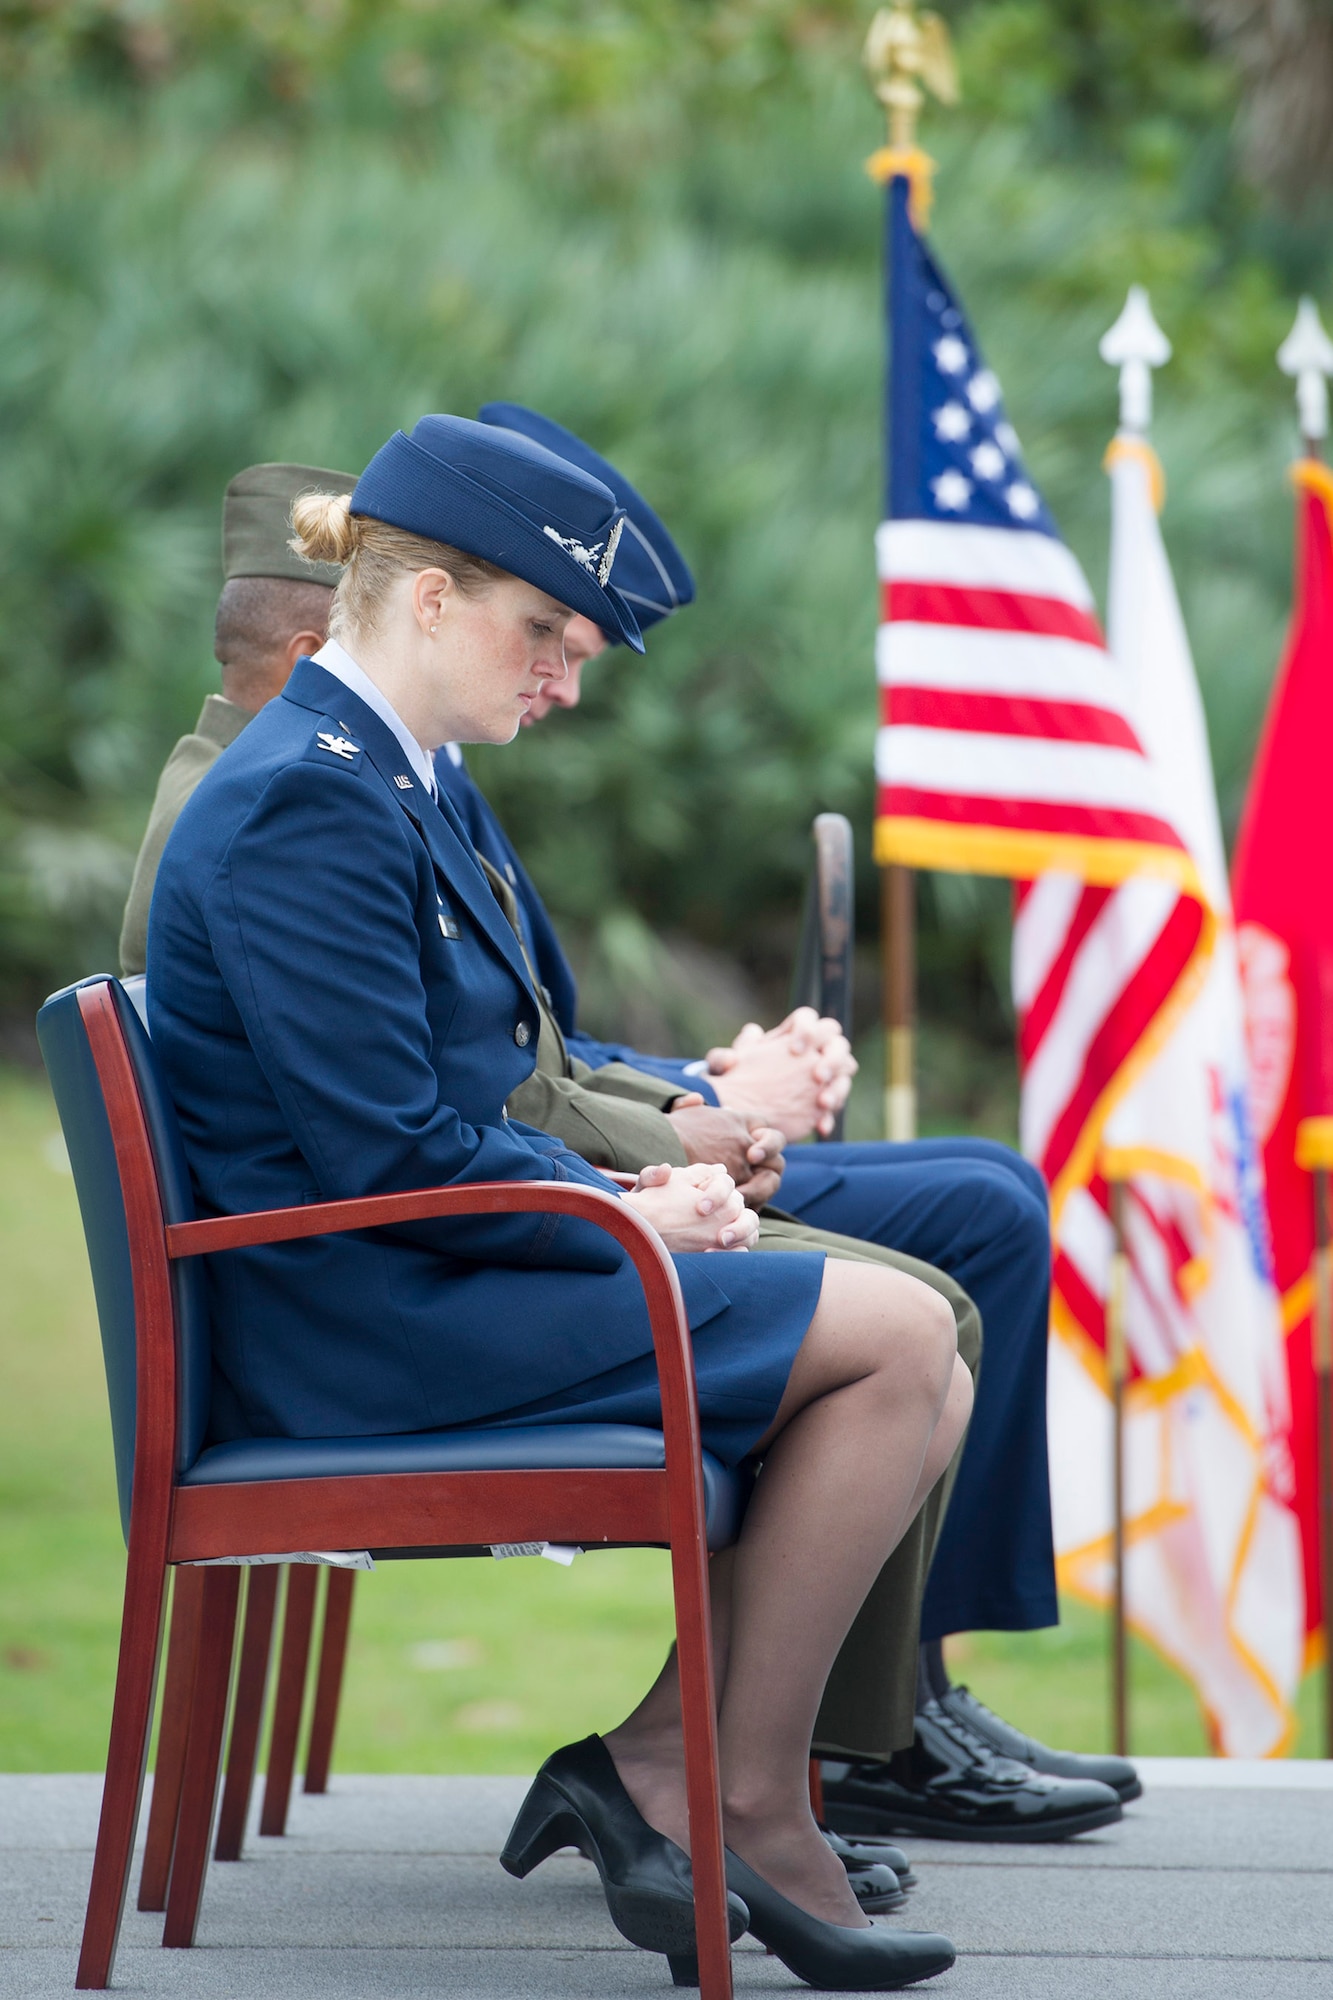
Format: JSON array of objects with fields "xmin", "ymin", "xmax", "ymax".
[{"xmin": 38, "ymin": 974, "xmax": 212, "ymax": 1536}]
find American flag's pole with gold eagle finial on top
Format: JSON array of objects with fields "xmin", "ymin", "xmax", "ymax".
[{"xmin": 865, "ymin": 0, "xmax": 959, "ymax": 1140}]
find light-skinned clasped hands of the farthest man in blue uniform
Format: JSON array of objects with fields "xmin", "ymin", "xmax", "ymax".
[{"xmin": 709, "ymin": 1008, "xmax": 857, "ymax": 1144}]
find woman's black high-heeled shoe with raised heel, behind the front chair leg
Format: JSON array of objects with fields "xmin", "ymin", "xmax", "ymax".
[{"xmin": 500, "ymin": 1736, "xmax": 751, "ymax": 1974}]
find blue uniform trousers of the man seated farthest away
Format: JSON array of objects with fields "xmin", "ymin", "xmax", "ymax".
[{"xmin": 777, "ymin": 1138, "xmax": 1059, "ymax": 1640}]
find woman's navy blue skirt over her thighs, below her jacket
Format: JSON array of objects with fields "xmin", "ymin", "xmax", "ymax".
[{"xmin": 466, "ymin": 1250, "xmax": 825, "ymax": 1466}]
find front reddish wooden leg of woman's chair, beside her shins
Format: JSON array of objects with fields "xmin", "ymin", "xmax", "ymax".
[{"xmin": 671, "ymin": 1524, "xmax": 731, "ymax": 2000}]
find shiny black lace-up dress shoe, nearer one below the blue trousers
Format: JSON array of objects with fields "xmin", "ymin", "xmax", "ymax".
[{"xmin": 825, "ymin": 1702, "xmax": 1121, "ymax": 1840}]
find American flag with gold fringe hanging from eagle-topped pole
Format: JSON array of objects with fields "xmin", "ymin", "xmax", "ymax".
[{"xmin": 875, "ymin": 178, "xmax": 1205, "ymax": 1208}]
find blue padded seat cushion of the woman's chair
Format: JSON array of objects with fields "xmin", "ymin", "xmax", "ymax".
[{"xmin": 180, "ymin": 1424, "xmax": 755, "ymax": 1548}]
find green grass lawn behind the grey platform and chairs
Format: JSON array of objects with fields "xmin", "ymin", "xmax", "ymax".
[{"xmin": 0, "ymin": 1072, "xmax": 1317, "ymax": 1772}]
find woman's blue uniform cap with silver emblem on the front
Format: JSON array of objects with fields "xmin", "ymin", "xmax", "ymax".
[{"xmin": 352, "ymin": 416, "xmax": 642, "ymax": 652}]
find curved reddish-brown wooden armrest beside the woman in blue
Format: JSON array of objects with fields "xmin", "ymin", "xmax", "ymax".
[{"xmin": 164, "ymin": 1178, "xmax": 705, "ymax": 1522}]
